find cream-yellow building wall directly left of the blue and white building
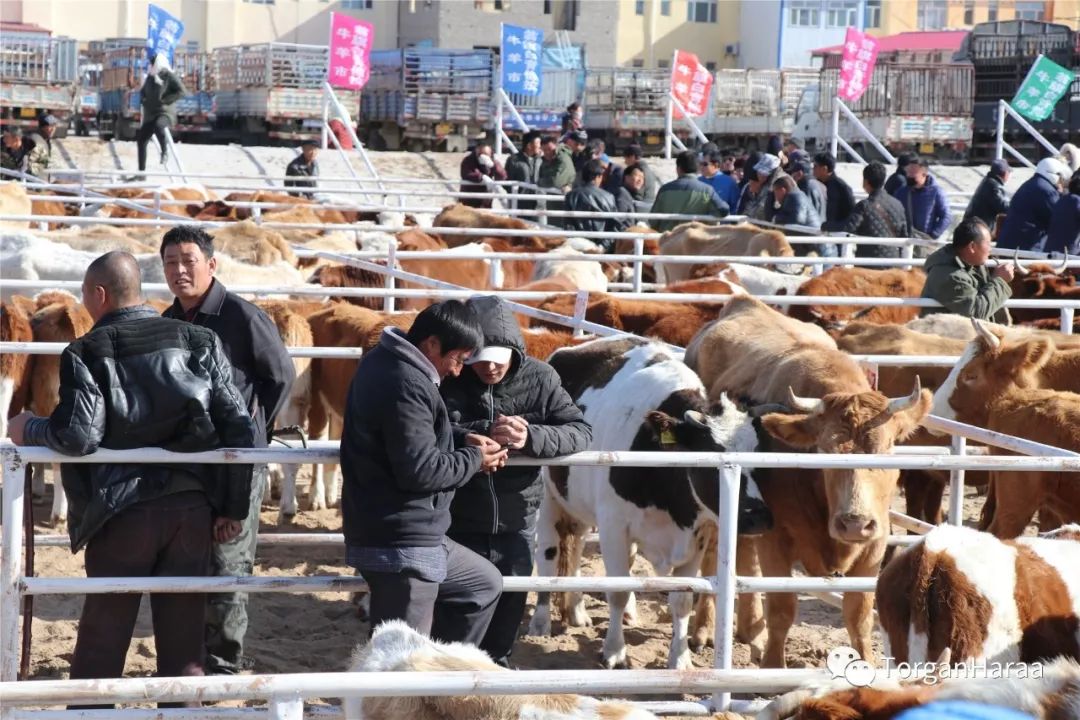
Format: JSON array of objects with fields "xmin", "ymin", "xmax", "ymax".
[{"xmin": 611, "ymin": 0, "xmax": 745, "ymax": 69}]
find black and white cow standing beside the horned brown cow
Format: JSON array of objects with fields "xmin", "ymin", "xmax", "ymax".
[{"xmin": 529, "ymin": 337, "xmax": 772, "ymax": 668}]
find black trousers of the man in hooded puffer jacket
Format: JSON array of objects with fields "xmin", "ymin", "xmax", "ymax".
[{"xmin": 451, "ymin": 527, "xmax": 536, "ymax": 666}]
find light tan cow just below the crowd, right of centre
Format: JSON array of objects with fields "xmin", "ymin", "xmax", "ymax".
[{"xmin": 656, "ymin": 221, "xmax": 795, "ymax": 283}]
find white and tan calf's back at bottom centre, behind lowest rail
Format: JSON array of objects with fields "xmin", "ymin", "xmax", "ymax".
[{"xmin": 341, "ymin": 620, "xmax": 656, "ymax": 720}]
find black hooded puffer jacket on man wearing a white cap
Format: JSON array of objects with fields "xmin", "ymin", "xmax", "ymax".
[{"xmin": 442, "ymin": 296, "xmax": 593, "ymax": 535}]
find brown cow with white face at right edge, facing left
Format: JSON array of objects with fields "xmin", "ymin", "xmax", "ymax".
[{"xmin": 934, "ymin": 321, "xmax": 1080, "ymax": 538}]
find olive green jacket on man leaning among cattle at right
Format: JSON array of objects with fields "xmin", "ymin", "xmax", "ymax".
[{"xmin": 920, "ymin": 245, "xmax": 1012, "ymax": 325}]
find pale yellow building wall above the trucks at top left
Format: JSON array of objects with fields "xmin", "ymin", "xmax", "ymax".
[{"xmin": 8, "ymin": 0, "xmax": 397, "ymax": 50}]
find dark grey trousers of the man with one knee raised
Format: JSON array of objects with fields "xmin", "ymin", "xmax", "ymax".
[{"xmin": 361, "ymin": 540, "xmax": 502, "ymax": 646}]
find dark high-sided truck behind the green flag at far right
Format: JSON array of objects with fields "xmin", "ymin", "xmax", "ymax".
[{"xmin": 958, "ymin": 21, "xmax": 1080, "ymax": 162}]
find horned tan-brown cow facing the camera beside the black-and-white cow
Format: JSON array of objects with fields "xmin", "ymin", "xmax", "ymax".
[{"xmin": 687, "ymin": 297, "xmax": 932, "ymax": 667}]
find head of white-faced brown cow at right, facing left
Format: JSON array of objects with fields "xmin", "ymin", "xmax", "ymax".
[{"xmin": 933, "ymin": 320, "xmax": 1054, "ymax": 427}]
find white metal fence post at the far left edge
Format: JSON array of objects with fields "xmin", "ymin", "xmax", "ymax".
[{"xmin": 0, "ymin": 448, "xmax": 25, "ymax": 682}]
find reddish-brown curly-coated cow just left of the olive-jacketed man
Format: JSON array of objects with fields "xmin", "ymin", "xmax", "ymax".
[{"xmin": 787, "ymin": 268, "xmax": 927, "ymax": 329}]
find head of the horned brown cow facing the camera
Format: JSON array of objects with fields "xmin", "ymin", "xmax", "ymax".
[{"xmin": 761, "ymin": 378, "xmax": 932, "ymax": 543}]
